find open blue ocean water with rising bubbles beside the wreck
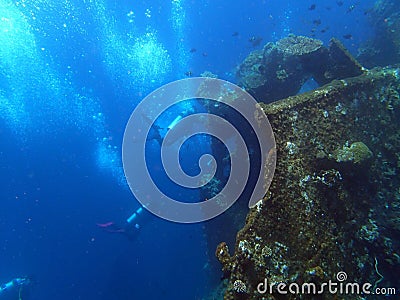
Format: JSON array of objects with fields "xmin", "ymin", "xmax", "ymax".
[{"xmin": 0, "ymin": 0, "xmax": 374, "ymax": 300}]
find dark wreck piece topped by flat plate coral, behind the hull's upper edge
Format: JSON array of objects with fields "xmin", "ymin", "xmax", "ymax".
[{"xmin": 237, "ymin": 35, "xmax": 364, "ymax": 103}]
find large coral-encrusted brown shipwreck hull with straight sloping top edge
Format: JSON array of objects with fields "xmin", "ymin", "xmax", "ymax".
[{"xmin": 216, "ymin": 69, "xmax": 400, "ymax": 299}]
